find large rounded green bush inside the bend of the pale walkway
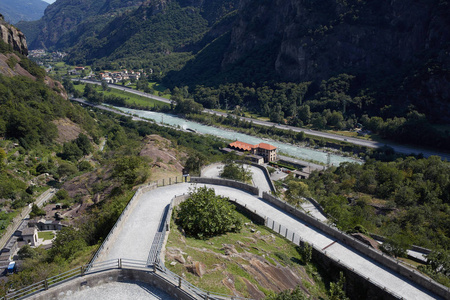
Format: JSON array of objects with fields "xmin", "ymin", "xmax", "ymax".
[{"xmin": 176, "ymin": 187, "xmax": 243, "ymax": 239}]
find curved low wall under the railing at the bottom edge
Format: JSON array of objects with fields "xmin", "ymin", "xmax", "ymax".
[{"xmin": 27, "ymin": 269, "xmax": 197, "ymax": 300}]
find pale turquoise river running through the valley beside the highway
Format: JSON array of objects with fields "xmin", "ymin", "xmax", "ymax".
[{"xmin": 111, "ymin": 105, "xmax": 360, "ymax": 166}]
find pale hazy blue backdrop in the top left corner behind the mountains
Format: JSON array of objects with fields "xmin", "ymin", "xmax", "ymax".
[{"xmin": 0, "ymin": 0, "xmax": 49, "ymax": 24}]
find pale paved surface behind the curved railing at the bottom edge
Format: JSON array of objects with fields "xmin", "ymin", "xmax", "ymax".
[{"xmin": 60, "ymin": 282, "xmax": 175, "ymax": 300}]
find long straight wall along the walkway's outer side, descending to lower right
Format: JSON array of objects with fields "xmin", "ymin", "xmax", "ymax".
[{"xmin": 263, "ymin": 193, "xmax": 450, "ymax": 299}]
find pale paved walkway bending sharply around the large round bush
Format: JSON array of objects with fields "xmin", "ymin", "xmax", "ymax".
[{"xmin": 90, "ymin": 183, "xmax": 436, "ymax": 299}]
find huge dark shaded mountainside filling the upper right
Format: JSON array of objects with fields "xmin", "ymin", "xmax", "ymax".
[{"xmin": 166, "ymin": 0, "xmax": 450, "ymax": 122}]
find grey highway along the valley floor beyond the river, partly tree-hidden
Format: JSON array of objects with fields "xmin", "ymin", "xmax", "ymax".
[{"xmin": 72, "ymin": 79, "xmax": 450, "ymax": 161}]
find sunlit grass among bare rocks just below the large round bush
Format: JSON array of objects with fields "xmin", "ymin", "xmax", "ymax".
[{"xmin": 166, "ymin": 213, "xmax": 326, "ymax": 297}]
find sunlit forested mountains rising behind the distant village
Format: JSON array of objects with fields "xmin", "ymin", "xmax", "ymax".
[{"xmin": 18, "ymin": 0, "xmax": 239, "ymax": 73}]
